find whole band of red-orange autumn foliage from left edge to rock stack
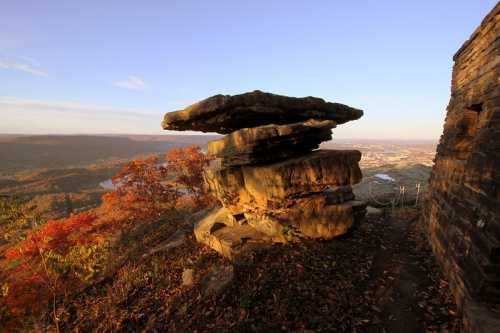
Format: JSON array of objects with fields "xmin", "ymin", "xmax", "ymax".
[{"xmin": 0, "ymin": 147, "xmax": 212, "ymax": 329}]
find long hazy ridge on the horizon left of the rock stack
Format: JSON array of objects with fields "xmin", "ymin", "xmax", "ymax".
[{"xmin": 0, "ymin": 135, "xmax": 219, "ymax": 175}]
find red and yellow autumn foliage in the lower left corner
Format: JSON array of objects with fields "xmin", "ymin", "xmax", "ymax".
[{"xmin": 0, "ymin": 212, "xmax": 105, "ymax": 324}]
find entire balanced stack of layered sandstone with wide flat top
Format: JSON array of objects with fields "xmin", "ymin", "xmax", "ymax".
[{"xmin": 162, "ymin": 91, "xmax": 366, "ymax": 258}]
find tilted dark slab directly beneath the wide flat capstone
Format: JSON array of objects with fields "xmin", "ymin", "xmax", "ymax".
[{"xmin": 208, "ymin": 119, "xmax": 336, "ymax": 167}]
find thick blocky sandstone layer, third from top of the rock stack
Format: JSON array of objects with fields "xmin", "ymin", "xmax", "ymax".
[{"xmin": 205, "ymin": 150, "xmax": 362, "ymax": 214}]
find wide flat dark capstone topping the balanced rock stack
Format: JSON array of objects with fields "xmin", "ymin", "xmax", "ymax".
[{"xmin": 162, "ymin": 90, "xmax": 363, "ymax": 134}]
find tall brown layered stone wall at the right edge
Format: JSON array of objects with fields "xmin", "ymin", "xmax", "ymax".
[{"xmin": 425, "ymin": 4, "xmax": 500, "ymax": 332}]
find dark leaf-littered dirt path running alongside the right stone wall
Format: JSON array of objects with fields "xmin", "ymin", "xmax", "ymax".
[{"xmin": 370, "ymin": 210, "xmax": 458, "ymax": 333}]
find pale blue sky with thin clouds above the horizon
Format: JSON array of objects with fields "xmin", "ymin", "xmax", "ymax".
[{"xmin": 0, "ymin": 0, "xmax": 497, "ymax": 139}]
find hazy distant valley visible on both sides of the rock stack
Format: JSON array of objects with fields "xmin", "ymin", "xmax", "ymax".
[{"xmin": 0, "ymin": 135, "xmax": 436, "ymax": 219}]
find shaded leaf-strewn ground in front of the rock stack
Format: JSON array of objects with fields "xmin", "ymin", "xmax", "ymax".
[{"xmin": 57, "ymin": 208, "xmax": 461, "ymax": 333}]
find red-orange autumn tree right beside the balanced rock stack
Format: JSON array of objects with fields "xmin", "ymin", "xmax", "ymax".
[{"xmin": 103, "ymin": 146, "xmax": 211, "ymax": 222}]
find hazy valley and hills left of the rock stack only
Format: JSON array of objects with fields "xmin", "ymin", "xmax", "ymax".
[{"xmin": 0, "ymin": 135, "xmax": 216, "ymax": 219}]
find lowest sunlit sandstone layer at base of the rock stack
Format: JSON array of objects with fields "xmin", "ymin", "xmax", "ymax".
[{"xmin": 195, "ymin": 194, "xmax": 366, "ymax": 244}]
